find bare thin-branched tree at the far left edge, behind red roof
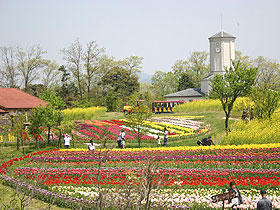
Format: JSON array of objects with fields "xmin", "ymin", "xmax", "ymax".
[{"xmin": 0, "ymin": 47, "xmax": 19, "ymax": 88}]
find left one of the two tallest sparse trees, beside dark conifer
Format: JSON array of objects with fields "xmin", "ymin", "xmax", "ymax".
[{"xmin": 61, "ymin": 40, "xmax": 84, "ymax": 98}]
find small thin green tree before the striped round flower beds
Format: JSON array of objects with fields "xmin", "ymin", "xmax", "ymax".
[{"xmin": 126, "ymin": 104, "xmax": 152, "ymax": 147}]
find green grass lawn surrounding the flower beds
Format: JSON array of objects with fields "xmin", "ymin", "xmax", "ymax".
[{"xmin": 0, "ymin": 111, "xmax": 234, "ymax": 210}]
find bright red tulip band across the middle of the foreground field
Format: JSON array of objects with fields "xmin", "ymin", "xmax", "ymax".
[{"xmin": 15, "ymin": 168, "xmax": 280, "ymax": 188}]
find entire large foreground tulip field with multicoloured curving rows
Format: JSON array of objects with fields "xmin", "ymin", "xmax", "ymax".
[{"xmin": 0, "ymin": 143, "xmax": 280, "ymax": 209}]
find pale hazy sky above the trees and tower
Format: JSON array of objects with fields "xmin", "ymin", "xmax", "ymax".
[{"xmin": 0, "ymin": 0, "xmax": 280, "ymax": 75}]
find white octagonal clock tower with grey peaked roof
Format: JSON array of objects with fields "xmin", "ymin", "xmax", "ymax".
[{"xmin": 201, "ymin": 31, "xmax": 236, "ymax": 94}]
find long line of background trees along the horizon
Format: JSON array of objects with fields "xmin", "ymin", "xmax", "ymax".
[{"xmin": 0, "ymin": 40, "xmax": 280, "ymax": 111}]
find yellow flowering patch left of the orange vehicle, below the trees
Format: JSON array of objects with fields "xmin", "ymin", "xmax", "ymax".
[{"xmin": 62, "ymin": 107, "xmax": 107, "ymax": 120}]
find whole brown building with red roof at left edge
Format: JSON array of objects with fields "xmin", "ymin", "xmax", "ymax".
[{"xmin": 0, "ymin": 88, "xmax": 47, "ymax": 130}]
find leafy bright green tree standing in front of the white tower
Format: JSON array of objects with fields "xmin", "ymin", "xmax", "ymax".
[{"xmin": 210, "ymin": 61, "xmax": 258, "ymax": 132}]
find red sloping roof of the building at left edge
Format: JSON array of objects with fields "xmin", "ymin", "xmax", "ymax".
[{"xmin": 0, "ymin": 88, "xmax": 47, "ymax": 109}]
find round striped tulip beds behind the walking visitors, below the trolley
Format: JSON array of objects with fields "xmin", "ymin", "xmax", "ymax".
[{"xmin": 17, "ymin": 116, "xmax": 209, "ymax": 143}]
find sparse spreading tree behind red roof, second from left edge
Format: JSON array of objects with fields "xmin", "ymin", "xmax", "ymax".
[{"xmin": 16, "ymin": 45, "xmax": 47, "ymax": 90}]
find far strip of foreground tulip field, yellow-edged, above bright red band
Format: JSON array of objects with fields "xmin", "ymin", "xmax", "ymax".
[{"xmin": 26, "ymin": 144, "xmax": 280, "ymax": 169}]
